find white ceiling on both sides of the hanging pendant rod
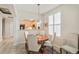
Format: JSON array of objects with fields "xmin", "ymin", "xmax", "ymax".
[{"xmin": 15, "ymin": 4, "xmax": 59, "ymax": 14}]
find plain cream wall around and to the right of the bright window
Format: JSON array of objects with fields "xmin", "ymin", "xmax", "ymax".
[{"xmin": 43, "ymin": 5, "xmax": 79, "ymax": 35}]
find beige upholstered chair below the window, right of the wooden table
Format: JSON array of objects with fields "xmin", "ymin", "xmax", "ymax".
[{"xmin": 52, "ymin": 36, "xmax": 64, "ymax": 53}]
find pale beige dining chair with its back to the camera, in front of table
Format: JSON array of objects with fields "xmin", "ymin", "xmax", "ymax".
[{"xmin": 27, "ymin": 34, "xmax": 41, "ymax": 53}]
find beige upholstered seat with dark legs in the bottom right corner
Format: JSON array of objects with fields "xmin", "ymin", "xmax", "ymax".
[{"xmin": 62, "ymin": 33, "xmax": 79, "ymax": 54}]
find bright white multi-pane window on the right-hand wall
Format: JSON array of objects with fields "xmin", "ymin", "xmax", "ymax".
[{"xmin": 49, "ymin": 12, "xmax": 61, "ymax": 36}]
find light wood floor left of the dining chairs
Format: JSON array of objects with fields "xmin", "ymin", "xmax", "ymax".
[{"xmin": 0, "ymin": 38, "xmax": 27, "ymax": 54}]
